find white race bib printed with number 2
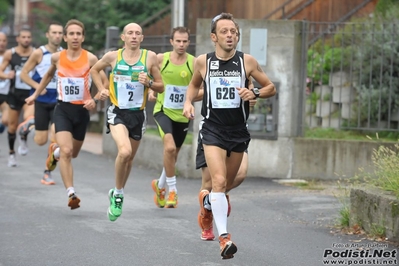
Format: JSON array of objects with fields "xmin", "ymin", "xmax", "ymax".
[{"xmin": 114, "ymin": 75, "xmax": 144, "ymax": 109}]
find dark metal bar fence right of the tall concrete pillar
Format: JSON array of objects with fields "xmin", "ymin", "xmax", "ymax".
[{"xmin": 303, "ymin": 22, "xmax": 399, "ymax": 131}]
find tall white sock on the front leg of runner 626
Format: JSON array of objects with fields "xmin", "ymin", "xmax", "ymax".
[{"xmin": 210, "ymin": 192, "xmax": 228, "ymax": 236}]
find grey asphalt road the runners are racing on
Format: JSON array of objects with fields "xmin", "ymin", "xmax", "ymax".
[{"xmin": 0, "ymin": 134, "xmax": 396, "ymax": 266}]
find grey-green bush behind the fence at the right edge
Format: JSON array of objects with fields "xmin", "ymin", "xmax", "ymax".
[{"xmin": 355, "ymin": 7, "xmax": 399, "ymax": 122}]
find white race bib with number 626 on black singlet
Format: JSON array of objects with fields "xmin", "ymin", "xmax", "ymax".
[{"xmin": 209, "ymin": 77, "xmax": 241, "ymax": 109}]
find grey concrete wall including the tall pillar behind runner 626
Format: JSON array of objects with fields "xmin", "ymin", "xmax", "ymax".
[{"xmin": 103, "ymin": 19, "xmax": 396, "ymax": 179}]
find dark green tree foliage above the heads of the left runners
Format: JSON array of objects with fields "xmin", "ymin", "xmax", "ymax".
[{"xmin": 34, "ymin": 0, "xmax": 171, "ymax": 52}]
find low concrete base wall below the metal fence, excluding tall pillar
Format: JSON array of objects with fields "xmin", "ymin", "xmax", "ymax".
[{"xmin": 103, "ymin": 131, "xmax": 394, "ymax": 180}]
